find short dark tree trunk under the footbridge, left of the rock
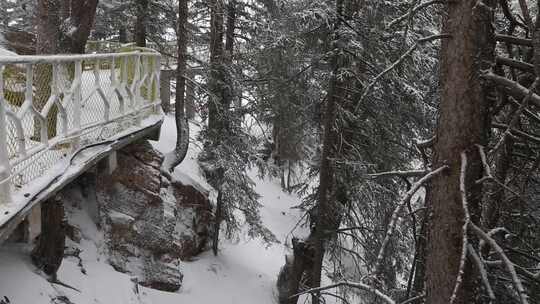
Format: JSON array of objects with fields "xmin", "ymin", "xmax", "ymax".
[{"xmin": 32, "ymin": 199, "xmax": 66, "ymax": 278}]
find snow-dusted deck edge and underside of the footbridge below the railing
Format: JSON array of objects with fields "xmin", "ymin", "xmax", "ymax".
[{"xmin": 0, "ymin": 115, "xmax": 163, "ymax": 245}]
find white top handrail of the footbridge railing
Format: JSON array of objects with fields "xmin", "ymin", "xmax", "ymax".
[{"xmin": 0, "ymin": 51, "xmax": 161, "ymax": 64}]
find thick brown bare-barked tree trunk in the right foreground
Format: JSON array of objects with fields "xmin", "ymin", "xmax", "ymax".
[{"xmin": 426, "ymin": 1, "xmax": 495, "ymax": 304}]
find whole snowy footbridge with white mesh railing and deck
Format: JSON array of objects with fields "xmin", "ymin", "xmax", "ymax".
[{"xmin": 0, "ymin": 50, "xmax": 163, "ymax": 244}]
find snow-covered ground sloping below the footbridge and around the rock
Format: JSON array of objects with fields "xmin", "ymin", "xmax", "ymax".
[{"xmin": 0, "ymin": 117, "xmax": 305, "ymax": 304}]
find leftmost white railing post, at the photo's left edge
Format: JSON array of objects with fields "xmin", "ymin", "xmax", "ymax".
[{"xmin": 0, "ymin": 66, "xmax": 11, "ymax": 205}]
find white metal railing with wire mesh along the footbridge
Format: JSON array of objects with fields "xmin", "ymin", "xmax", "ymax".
[{"xmin": 0, "ymin": 51, "xmax": 161, "ymax": 205}]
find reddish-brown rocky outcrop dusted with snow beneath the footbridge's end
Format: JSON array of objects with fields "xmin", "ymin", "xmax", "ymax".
[{"xmin": 96, "ymin": 141, "xmax": 211, "ymax": 291}]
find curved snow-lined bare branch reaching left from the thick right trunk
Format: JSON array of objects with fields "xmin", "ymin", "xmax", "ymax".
[{"xmin": 375, "ymin": 166, "xmax": 448, "ymax": 275}]
